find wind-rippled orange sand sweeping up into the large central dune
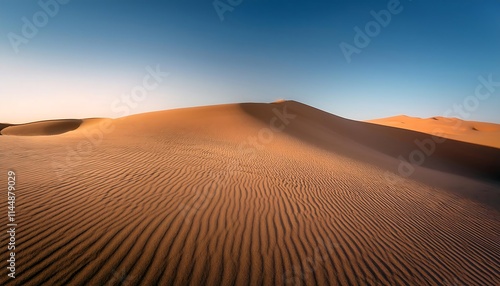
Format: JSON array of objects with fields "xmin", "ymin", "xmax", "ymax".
[{"xmin": 0, "ymin": 102, "xmax": 500, "ymax": 285}]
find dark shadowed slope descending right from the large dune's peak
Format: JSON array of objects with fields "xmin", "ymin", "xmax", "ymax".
[{"xmin": 241, "ymin": 101, "xmax": 500, "ymax": 180}]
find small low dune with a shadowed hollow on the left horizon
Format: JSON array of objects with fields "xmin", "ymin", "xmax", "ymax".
[{"xmin": 0, "ymin": 119, "xmax": 83, "ymax": 136}]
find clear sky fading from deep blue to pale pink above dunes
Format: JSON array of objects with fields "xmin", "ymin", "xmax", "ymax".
[{"xmin": 0, "ymin": 0, "xmax": 500, "ymax": 123}]
